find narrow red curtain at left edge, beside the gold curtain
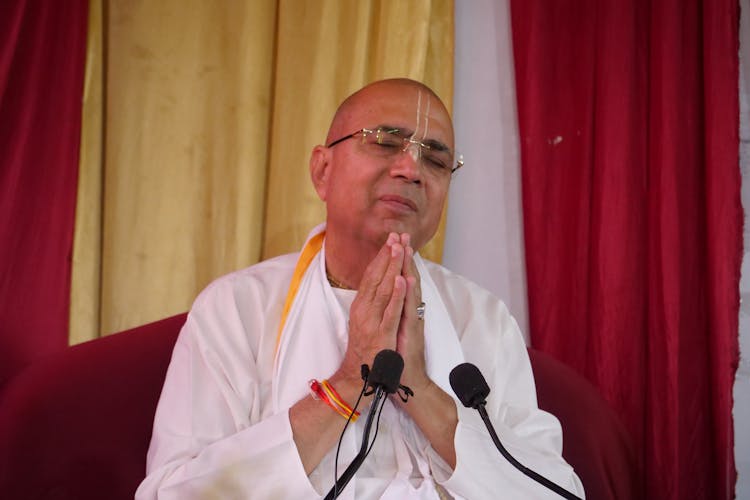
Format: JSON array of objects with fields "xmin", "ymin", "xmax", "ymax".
[{"xmin": 0, "ymin": 0, "xmax": 88, "ymax": 383}]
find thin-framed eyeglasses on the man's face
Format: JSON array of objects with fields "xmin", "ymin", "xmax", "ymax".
[{"xmin": 326, "ymin": 128, "xmax": 464, "ymax": 175}]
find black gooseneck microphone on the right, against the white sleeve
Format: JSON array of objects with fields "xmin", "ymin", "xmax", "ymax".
[{"xmin": 448, "ymin": 363, "xmax": 581, "ymax": 500}]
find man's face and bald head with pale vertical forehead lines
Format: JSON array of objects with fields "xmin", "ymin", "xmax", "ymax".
[{"xmin": 316, "ymin": 82, "xmax": 453, "ymax": 254}]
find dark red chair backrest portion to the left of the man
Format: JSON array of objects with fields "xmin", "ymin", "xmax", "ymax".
[{"xmin": 0, "ymin": 314, "xmax": 185, "ymax": 500}]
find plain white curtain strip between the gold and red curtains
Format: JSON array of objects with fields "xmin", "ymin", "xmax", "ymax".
[{"xmin": 443, "ymin": 0, "xmax": 529, "ymax": 342}]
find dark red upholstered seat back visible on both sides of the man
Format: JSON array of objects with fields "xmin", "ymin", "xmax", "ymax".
[{"xmin": 0, "ymin": 314, "xmax": 637, "ymax": 500}]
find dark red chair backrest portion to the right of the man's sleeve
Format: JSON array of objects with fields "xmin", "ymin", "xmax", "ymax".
[{"xmin": 529, "ymin": 349, "xmax": 642, "ymax": 500}]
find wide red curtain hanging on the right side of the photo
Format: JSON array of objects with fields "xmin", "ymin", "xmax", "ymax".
[{"xmin": 511, "ymin": 0, "xmax": 742, "ymax": 499}]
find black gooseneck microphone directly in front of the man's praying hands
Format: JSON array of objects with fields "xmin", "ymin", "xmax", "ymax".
[{"xmin": 325, "ymin": 349, "xmax": 404, "ymax": 500}]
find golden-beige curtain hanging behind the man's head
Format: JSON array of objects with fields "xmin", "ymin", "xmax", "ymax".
[{"xmin": 71, "ymin": 0, "xmax": 453, "ymax": 343}]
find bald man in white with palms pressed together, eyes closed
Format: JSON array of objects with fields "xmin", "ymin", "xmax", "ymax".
[{"xmin": 136, "ymin": 79, "xmax": 582, "ymax": 499}]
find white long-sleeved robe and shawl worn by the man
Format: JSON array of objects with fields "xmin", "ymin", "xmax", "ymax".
[{"xmin": 136, "ymin": 229, "xmax": 583, "ymax": 500}]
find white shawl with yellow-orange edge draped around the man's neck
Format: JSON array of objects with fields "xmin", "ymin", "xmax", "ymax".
[{"xmin": 272, "ymin": 224, "xmax": 464, "ymax": 498}]
